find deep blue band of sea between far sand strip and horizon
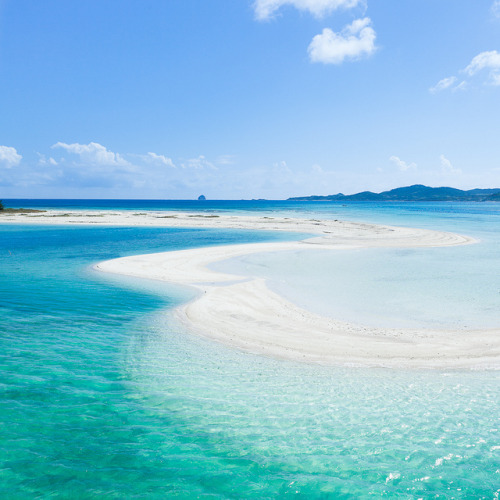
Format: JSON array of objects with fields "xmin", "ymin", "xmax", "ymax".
[{"xmin": 4, "ymin": 195, "xmax": 500, "ymax": 236}]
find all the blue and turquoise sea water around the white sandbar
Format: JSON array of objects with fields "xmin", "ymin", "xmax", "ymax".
[{"xmin": 0, "ymin": 200, "xmax": 500, "ymax": 499}]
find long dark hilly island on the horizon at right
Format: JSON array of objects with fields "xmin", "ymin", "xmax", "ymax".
[{"xmin": 288, "ymin": 184, "xmax": 500, "ymax": 201}]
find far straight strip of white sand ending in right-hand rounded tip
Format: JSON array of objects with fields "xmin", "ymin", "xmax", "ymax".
[{"xmin": 0, "ymin": 210, "xmax": 476, "ymax": 247}]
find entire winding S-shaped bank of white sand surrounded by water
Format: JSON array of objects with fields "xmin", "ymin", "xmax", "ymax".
[{"xmin": 0, "ymin": 211, "xmax": 500, "ymax": 369}]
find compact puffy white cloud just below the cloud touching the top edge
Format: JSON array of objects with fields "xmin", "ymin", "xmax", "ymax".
[{"xmin": 308, "ymin": 17, "xmax": 376, "ymax": 64}]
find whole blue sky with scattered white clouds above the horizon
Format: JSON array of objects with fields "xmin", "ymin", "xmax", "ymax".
[{"xmin": 0, "ymin": 0, "xmax": 500, "ymax": 199}]
